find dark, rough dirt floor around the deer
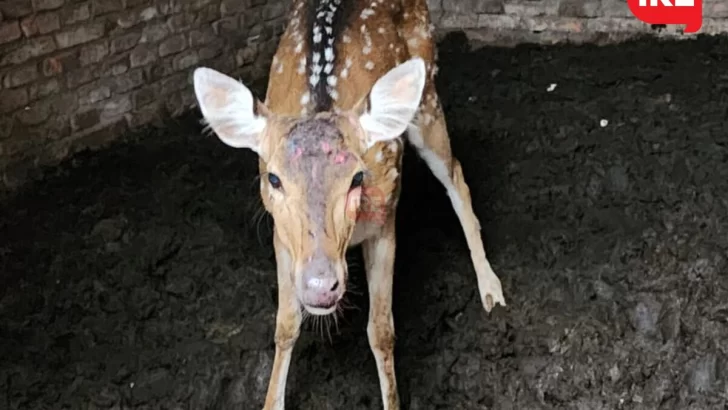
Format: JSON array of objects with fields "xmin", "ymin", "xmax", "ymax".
[{"xmin": 0, "ymin": 32, "xmax": 728, "ymax": 410}]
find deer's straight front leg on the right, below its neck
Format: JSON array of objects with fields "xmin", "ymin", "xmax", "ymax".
[{"xmin": 362, "ymin": 216, "xmax": 399, "ymax": 410}]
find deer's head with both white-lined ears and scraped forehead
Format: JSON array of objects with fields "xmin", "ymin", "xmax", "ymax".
[{"xmin": 194, "ymin": 58, "xmax": 426, "ymax": 315}]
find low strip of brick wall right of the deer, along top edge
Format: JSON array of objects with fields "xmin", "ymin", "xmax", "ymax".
[{"xmin": 428, "ymin": 0, "xmax": 728, "ymax": 45}]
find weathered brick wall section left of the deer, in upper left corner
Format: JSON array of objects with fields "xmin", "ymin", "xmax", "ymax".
[{"xmin": 0, "ymin": 0, "xmax": 289, "ymax": 188}]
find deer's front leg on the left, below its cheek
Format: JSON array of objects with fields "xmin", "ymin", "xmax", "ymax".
[{"xmin": 263, "ymin": 237, "xmax": 301, "ymax": 410}]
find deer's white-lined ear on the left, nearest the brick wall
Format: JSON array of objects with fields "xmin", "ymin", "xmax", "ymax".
[{"xmin": 193, "ymin": 67, "xmax": 268, "ymax": 155}]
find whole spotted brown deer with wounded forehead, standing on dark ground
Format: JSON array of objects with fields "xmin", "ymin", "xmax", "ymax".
[{"xmin": 193, "ymin": 0, "xmax": 506, "ymax": 410}]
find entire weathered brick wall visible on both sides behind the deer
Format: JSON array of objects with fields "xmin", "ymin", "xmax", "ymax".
[{"xmin": 0, "ymin": 0, "xmax": 728, "ymax": 191}]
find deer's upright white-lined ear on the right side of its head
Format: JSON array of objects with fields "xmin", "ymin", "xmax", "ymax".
[{"xmin": 355, "ymin": 57, "xmax": 426, "ymax": 149}]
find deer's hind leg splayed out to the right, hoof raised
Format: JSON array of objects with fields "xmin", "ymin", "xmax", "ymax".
[{"xmin": 407, "ymin": 91, "xmax": 506, "ymax": 312}]
